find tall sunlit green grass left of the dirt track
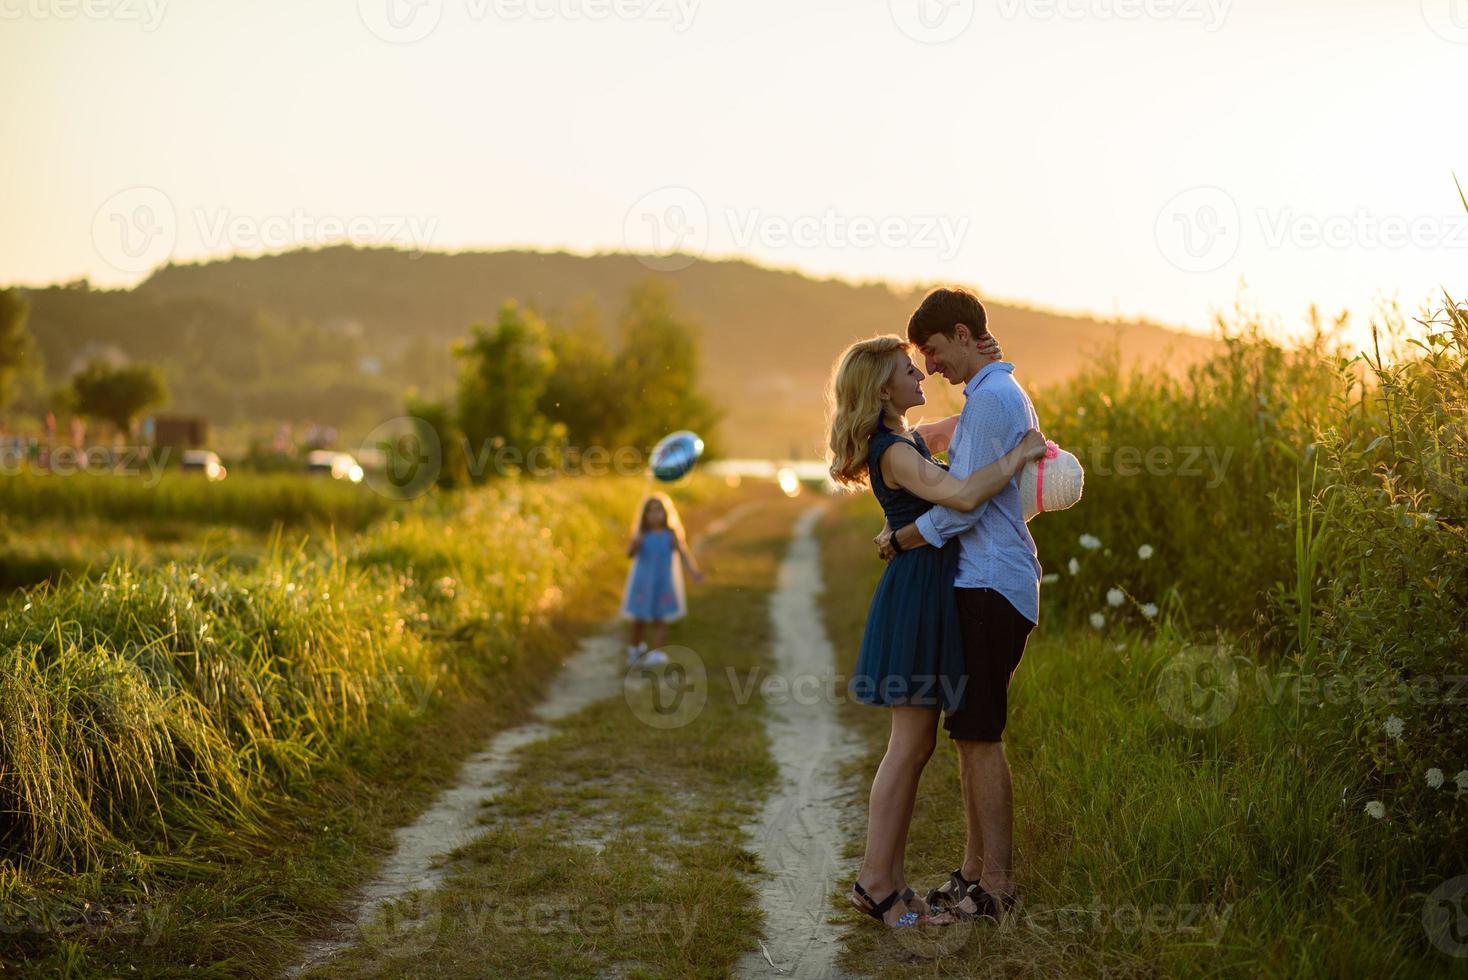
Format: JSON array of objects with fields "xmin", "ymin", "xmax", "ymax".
[{"xmin": 0, "ymin": 480, "xmax": 642, "ymax": 895}]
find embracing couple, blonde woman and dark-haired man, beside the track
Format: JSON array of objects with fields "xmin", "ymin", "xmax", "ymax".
[{"xmin": 829, "ymin": 289, "xmax": 1047, "ymax": 929}]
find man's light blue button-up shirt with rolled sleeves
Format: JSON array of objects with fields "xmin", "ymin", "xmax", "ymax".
[{"xmin": 918, "ymin": 361, "xmax": 1041, "ymax": 624}]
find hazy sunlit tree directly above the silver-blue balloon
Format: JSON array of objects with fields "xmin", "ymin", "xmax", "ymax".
[{"xmin": 612, "ymin": 282, "xmax": 719, "ymax": 449}]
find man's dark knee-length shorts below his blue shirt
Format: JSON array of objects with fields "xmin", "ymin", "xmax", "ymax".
[{"xmin": 942, "ymin": 588, "xmax": 1035, "ymax": 742}]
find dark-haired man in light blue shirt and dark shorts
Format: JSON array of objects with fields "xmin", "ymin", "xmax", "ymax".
[{"xmin": 878, "ymin": 289, "xmax": 1041, "ymax": 923}]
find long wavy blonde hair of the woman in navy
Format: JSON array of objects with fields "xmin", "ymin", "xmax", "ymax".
[{"xmin": 826, "ymin": 333, "xmax": 912, "ymax": 490}]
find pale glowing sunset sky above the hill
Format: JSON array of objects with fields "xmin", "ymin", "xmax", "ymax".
[{"xmin": 0, "ymin": 0, "xmax": 1468, "ymax": 346}]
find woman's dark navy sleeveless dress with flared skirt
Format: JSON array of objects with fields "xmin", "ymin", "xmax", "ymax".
[{"xmin": 849, "ymin": 421, "xmax": 967, "ymax": 712}]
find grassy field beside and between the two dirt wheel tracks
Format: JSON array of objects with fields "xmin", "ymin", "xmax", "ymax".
[{"xmin": 0, "ymin": 293, "xmax": 1468, "ymax": 977}]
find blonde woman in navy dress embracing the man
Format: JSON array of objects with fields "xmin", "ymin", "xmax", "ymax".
[{"xmin": 828, "ymin": 336, "xmax": 1045, "ymax": 929}]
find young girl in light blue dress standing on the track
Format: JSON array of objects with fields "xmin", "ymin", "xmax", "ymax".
[{"xmin": 622, "ymin": 493, "xmax": 703, "ymax": 666}]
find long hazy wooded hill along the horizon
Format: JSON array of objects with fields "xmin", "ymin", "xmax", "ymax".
[{"xmin": 22, "ymin": 246, "xmax": 1214, "ymax": 456}]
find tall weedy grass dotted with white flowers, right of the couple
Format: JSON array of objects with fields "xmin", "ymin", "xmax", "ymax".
[{"xmin": 1031, "ymin": 299, "xmax": 1468, "ymax": 921}]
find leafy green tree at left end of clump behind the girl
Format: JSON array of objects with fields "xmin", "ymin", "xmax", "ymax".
[{"xmin": 454, "ymin": 302, "xmax": 564, "ymax": 477}]
